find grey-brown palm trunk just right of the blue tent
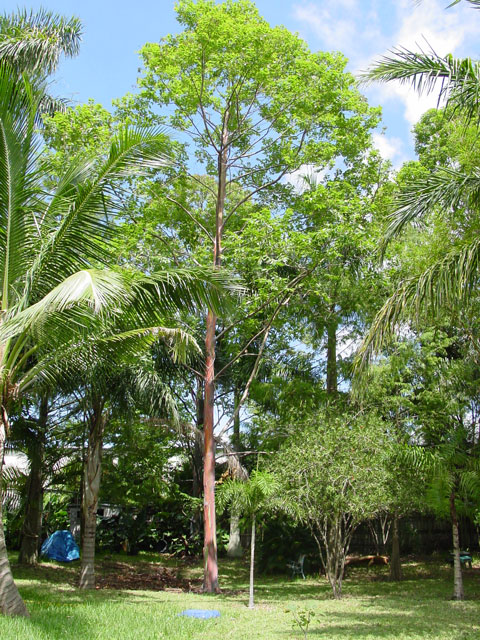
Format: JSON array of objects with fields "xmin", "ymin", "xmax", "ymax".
[{"xmin": 79, "ymin": 400, "xmax": 106, "ymax": 589}]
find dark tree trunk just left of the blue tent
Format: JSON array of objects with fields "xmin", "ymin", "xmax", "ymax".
[{"xmin": 18, "ymin": 396, "xmax": 48, "ymax": 565}]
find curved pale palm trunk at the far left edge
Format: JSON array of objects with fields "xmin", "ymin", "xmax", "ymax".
[{"xmin": 0, "ymin": 406, "xmax": 29, "ymax": 617}]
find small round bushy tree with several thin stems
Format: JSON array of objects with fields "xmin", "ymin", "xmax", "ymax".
[{"xmin": 273, "ymin": 411, "xmax": 389, "ymax": 598}]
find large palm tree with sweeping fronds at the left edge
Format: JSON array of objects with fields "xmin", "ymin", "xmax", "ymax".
[{"xmin": 0, "ymin": 62, "xmax": 234, "ymax": 615}]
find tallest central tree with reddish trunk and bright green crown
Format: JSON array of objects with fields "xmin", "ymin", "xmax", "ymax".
[{"xmin": 140, "ymin": 0, "xmax": 378, "ymax": 592}]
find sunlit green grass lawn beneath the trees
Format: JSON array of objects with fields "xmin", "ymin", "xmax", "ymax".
[{"xmin": 0, "ymin": 554, "xmax": 480, "ymax": 640}]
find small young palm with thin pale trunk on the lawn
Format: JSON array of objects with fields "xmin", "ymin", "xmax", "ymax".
[{"xmin": 217, "ymin": 470, "xmax": 279, "ymax": 609}]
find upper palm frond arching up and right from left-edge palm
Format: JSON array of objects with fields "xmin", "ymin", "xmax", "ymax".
[{"xmin": 25, "ymin": 127, "xmax": 169, "ymax": 298}]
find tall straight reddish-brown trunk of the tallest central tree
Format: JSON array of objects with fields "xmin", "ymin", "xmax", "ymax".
[{"xmin": 203, "ymin": 110, "xmax": 230, "ymax": 593}]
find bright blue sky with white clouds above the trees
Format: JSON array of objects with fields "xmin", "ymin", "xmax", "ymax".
[{"xmin": 1, "ymin": 0, "xmax": 480, "ymax": 166}]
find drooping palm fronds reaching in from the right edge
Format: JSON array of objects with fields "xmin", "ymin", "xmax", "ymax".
[{"xmin": 357, "ymin": 0, "xmax": 480, "ymax": 366}]
